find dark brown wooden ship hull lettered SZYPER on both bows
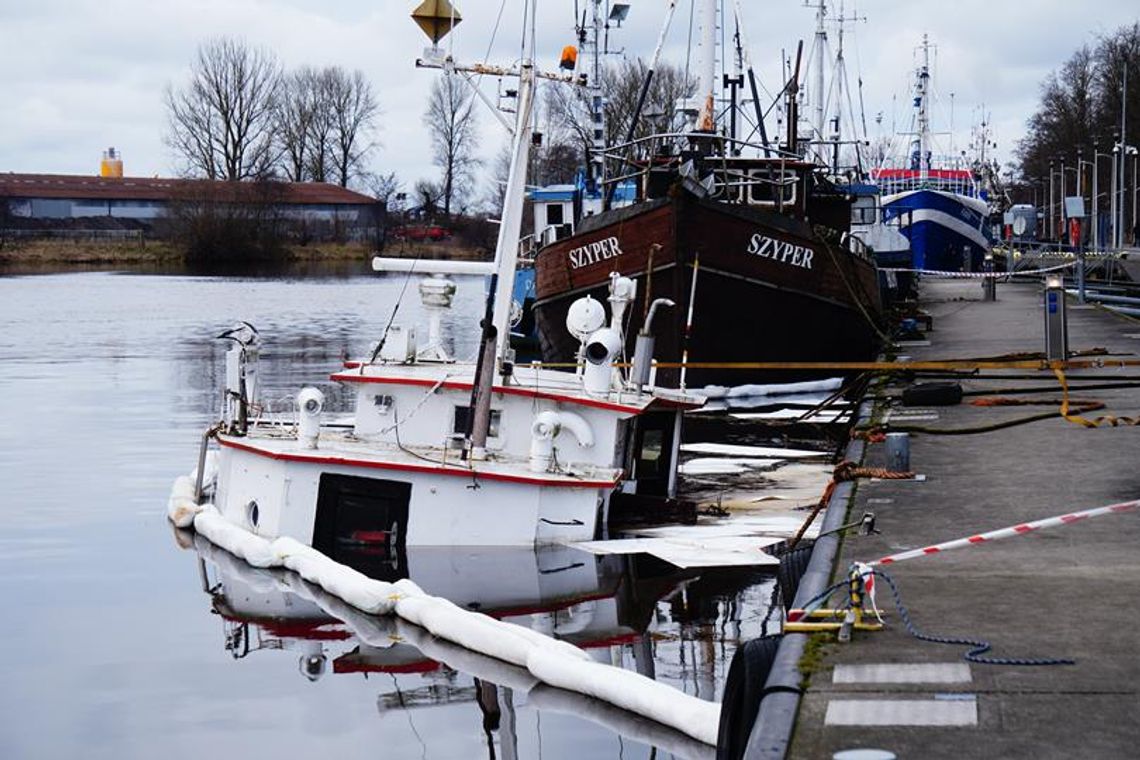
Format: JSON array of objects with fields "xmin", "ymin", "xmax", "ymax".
[{"xmin": 534, "ymin": 187, "xmax": 881, "ymax": 387}]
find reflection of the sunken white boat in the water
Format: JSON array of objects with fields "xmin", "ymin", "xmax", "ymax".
[{"xmin": 178, "ymin": 531, "xmax": 774, "ymax": 758}]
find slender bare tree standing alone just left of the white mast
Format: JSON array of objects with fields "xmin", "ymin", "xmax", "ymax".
[{"xmin": 428, "ymin": 74, "xmax": 480, "ymax": 216}]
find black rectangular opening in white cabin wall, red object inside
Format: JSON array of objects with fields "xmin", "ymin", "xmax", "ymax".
[{"xmin": 312, "ymin": 474, "xmax": 412, "ymax": 581}]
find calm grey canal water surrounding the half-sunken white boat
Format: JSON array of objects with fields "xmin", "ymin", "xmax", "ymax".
[{"xmin": 0, "ymin": 264, "xmax": 772, "ymax": 759}]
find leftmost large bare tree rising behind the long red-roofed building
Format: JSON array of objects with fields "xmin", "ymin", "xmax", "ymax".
[{"xmin": 165, "ymin": 38, "xmax": 280, "ymax": 180}]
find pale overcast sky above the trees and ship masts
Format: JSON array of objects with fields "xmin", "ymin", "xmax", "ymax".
[{"xmin": 0, "ymin": 0, "xmax": 1140, "ymax": 193}]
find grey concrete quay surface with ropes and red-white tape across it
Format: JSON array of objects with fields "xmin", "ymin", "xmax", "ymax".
[{"xmin": 788, "ymin": 280, "xmax": 1140, "ymax": 760}]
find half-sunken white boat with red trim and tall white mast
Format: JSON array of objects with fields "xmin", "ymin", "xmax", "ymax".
[{"xmin": 175, "ymin": 32, "xmax": 703, "ymax": 556}]
